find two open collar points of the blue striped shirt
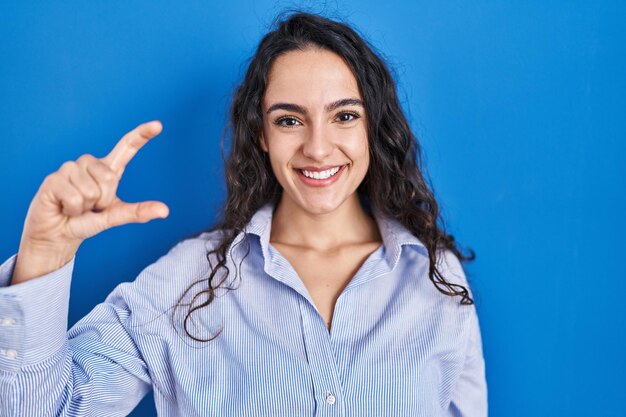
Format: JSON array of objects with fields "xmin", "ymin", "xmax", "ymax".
[{"xmin": 242, "ymin": 203, "xmax": 426, "ymax": 269}]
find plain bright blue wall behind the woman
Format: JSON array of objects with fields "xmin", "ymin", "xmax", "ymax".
[{"xmin": 0, "ymin": 0, "xmax": 626, "ymax": 417}]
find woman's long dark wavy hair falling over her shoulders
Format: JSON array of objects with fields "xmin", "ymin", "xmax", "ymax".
[{"xmin": 176, "ymin": 12, "xmax": 474, "ymax": 342}]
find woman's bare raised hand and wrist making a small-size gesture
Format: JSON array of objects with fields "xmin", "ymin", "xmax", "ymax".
[{"xmin": 12, "ymin": 121, "xmax": 169, "ymax": 284}]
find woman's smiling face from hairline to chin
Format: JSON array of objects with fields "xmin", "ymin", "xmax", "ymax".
[{"xmin": 260, "ymin": 48, "xmax": 369, "ymax": 214}]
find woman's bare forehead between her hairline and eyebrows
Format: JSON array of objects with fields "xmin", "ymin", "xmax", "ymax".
[{"xmin": 263, "ymin": 48, "xmax": 361, "ymax": 106}]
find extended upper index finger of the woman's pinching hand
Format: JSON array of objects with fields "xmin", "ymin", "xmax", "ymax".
[{"xmin": 102, "ymin": 120, "xmax": 163, "ymax": 178}]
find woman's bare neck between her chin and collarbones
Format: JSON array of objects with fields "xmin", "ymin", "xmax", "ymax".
[{"xmin": 270, "ymin": 194, "xmax": 381, "ymax": 251}]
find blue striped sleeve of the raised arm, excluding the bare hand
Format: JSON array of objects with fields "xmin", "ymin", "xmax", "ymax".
[{"xmin": 0, "ymin": 257, "xmax": 151, "ymax": 417}]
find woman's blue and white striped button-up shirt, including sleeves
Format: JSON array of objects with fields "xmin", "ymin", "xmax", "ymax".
[{"xmin": 0, "ymin": 206, "xmax": 487, "ymax": 417}]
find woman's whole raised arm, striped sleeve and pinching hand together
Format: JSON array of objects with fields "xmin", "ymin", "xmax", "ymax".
[{"xmin": 0, "ymin": 122, "xmax": 169, "ymax": 417}]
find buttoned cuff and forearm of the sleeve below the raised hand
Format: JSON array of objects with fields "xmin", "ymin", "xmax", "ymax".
[{"xmin": 0, "ymin": 255, "xmax": 75, "ymax": 373}]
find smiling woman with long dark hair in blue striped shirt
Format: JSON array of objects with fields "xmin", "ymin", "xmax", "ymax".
[{"xmin": 0, "ymin": 13, "xmax": 486, "ymax": 417}]
